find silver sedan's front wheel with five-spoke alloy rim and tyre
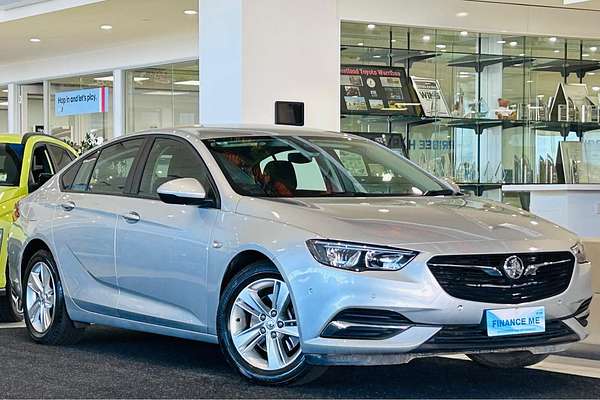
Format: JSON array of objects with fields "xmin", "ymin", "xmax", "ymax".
[{"xmin": 217, "ymin": 262, "xmax": 324, "ymax": 385}]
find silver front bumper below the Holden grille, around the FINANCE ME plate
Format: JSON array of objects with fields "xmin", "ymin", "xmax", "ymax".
[{"xmin": 286, "ymin": 247, "xmax": 592, "ymax": 365}]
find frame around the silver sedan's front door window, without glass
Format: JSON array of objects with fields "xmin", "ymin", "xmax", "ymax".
[{"xmin": 128, "ymin": 133, "xmax": 221, "ymax": 209}]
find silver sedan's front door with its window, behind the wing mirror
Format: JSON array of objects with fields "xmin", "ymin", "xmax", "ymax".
[{"xmin": 116, "ymin": 137, "xmax": 219, "ymax": 332}]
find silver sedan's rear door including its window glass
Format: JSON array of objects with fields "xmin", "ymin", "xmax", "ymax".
[{"xmin": 53, "ymin": 138, "xmax": 145, "ymax": 315}]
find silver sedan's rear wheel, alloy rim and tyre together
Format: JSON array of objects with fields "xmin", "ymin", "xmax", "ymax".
[{"xmin": 23, "ymin": 250, "xmax": 83, "ymax": 345}]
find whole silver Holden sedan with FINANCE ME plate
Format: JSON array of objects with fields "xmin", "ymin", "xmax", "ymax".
[{"xmin": 9, "ymin": 127, "xmax": 592, "ymax": 384}]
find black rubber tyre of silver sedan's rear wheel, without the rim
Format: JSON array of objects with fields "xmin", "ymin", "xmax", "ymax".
[{"xmin": 23, "ymin": 250, "xmax": 84, "ymax": 345}]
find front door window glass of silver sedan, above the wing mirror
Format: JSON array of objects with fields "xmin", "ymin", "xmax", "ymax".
[{"xmin": 139, "ymin": 138, "xmax": 211, "ymax": 198}]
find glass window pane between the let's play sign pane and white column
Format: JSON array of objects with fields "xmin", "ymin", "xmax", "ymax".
[{"xmin": 125, "ymin": 61, "xmax": 200, "ymax": 132}]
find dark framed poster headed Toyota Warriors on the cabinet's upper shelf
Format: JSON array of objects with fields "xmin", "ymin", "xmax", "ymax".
[{"xmin": 340, "ymin": 66, "xmax": 420, "ymax": 115}]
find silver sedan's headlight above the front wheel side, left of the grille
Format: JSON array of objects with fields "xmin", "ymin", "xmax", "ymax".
[{"xmin": 306, "ymin": 240, "xmax": 419, "ymax": 272}]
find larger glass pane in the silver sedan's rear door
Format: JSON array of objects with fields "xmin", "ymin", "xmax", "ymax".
[{"xmin": 88, "ymin": 139, "xmax": 144, "ymax": 194}]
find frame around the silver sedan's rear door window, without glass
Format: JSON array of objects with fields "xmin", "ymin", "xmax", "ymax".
[{"xmin": 59, "ymin": 135, "xmax": 150, "ymax": 197}]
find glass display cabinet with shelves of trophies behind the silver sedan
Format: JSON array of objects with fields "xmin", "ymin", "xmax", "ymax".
[{"xmin": 341, "ymin": 22, "xmax": 600, "ymax": 197}]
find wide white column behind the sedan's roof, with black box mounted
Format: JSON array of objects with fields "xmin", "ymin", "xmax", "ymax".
[{"xmin": 199, "ymin": 0, "xmax": 340, "ymax": 130}]
